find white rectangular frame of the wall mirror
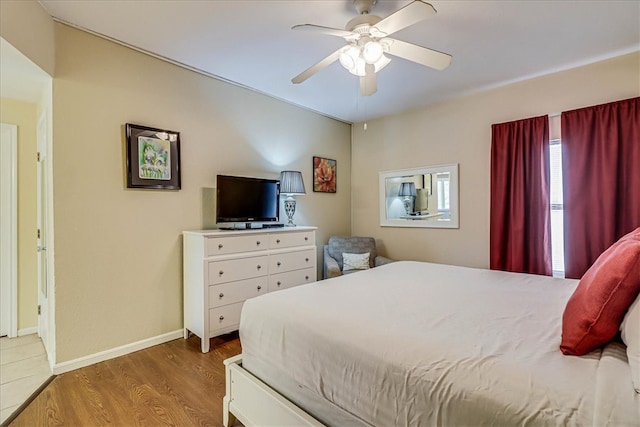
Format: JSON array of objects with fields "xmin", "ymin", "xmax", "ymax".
[{"xmin": 379, "ymin": 163, "xmax": 460, "ymax": 228}]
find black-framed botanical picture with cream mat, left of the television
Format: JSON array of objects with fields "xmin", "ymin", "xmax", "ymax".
[{"xmin": 126, "ymin": 123, "xmax": 180, "ymax": 190}]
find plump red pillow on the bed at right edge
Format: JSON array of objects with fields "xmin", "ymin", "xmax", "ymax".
[{"xmin": 560, "ymin": 228, "xmax": 640, "ymax": 356}]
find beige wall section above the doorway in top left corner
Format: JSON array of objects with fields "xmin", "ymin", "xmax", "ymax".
[{"xmin": 0, "ymin": 0, "xmax": 55, "ymax": 76}]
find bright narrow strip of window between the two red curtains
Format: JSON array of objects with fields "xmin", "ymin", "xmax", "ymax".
[{"xmin": 549, "ymin": 139, "xmax": 564, "ymax": 277}]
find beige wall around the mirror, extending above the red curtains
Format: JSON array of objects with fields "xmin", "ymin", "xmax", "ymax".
[{"xmin": 351, "ymin": 53, "xmax": 640, "ymax": 267}]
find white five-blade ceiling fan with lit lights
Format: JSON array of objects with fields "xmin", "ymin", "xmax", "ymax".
[{"xmin": 291, "ymin": 0, "xmax": 451, "ymax": 96}]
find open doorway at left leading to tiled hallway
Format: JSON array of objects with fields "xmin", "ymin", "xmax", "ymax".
[{"xmin": 0, "ymin": 37, "xmax": 56, "ymax": 423}]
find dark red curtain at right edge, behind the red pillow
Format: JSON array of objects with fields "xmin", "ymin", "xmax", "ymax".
[{"xmin": 562, "ymin": 98, "xmax": 640, "ymax": 279}]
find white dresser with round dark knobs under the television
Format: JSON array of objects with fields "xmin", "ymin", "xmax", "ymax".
[{"xmin": 183, "ymin": 227, "xmax": 317, "ymax": 353}]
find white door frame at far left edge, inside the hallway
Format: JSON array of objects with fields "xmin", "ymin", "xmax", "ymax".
[{"xmin": 0, "ymin": 123, "xmax": 18, "ymax": 338}]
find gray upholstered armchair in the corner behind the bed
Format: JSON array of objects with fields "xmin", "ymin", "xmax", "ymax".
[{"xmin": 322, "ymin": 236, "xmax": 394, "ymax": 279}]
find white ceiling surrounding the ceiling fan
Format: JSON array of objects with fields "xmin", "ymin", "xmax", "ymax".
[{"xmin": 28, "ymin": 0, "xmax": 640, "ymax": 122}]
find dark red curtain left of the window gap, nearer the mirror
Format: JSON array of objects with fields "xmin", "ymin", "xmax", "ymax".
[{"xmin": 490, "ymin": 116, "xmax": 551, "ymax": 276}]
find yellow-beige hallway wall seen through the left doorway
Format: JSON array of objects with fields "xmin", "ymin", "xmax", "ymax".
[{"xmin": 0, "ymin": 98, "xmax": 38, "ymax": 332}]
